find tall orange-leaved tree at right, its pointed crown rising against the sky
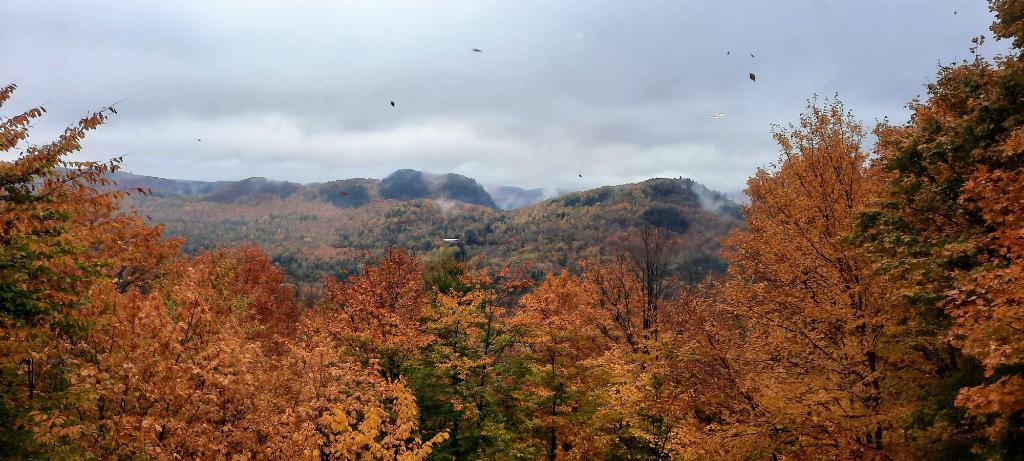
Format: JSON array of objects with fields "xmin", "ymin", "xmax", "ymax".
[{"xmin": 723, "ymin": 100, "xmax": 924, "ymax": 457}]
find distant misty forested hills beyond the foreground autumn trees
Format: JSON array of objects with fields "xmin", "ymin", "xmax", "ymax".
[{"xmin": 128, "ymin": 170, "xmax": 741, "ymax": 283}]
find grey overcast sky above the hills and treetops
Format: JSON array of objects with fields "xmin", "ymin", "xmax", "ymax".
[{"xmin": 0, "ymin": 0, "xmax": 1006, "ymax": 192}]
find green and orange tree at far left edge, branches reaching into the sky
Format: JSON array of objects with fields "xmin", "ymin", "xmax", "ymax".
[{"xmin": 0, "ymin": 85, "xmax": 177, "ymax": 456}]
